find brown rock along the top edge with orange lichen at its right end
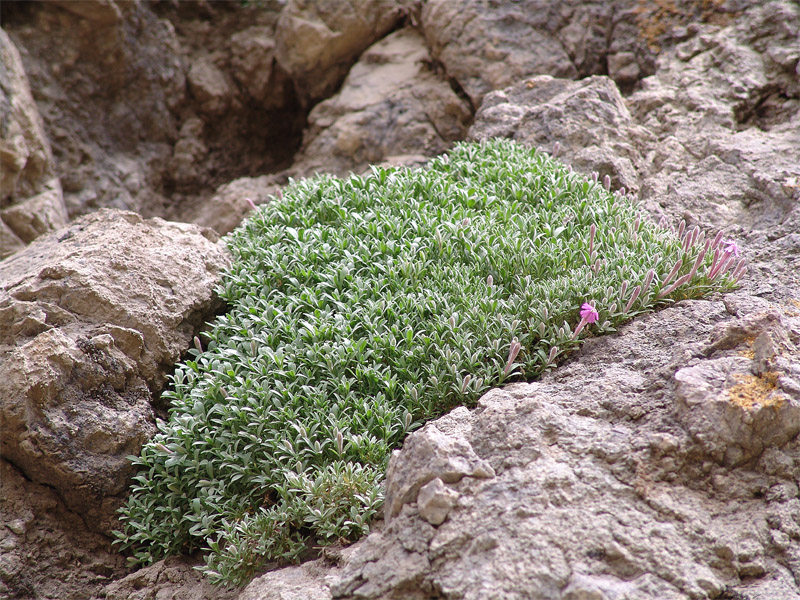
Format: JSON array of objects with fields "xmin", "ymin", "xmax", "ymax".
[{"xmin": 420, "ymin": 0, "xmax": 746, "ymax": 108}]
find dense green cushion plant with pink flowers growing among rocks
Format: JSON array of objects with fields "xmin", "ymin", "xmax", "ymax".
[{"xmin": 112, "ymin": 140, "xmax": 744, "ymax": 584}]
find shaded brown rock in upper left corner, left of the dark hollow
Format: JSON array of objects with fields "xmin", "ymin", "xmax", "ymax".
[{"xmin": 3, "ymin": 0, "xmax": 185, "ymax": 218}]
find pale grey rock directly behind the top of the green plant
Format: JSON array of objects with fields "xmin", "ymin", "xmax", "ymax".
[{"xmin": 468, "ymin": 75, "xmax": 649, "ymax": 191}]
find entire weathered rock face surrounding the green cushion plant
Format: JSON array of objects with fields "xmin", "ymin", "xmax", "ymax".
[{"xmin": 0, "ymin": 0, "xmax": 800, "ymax": 600}]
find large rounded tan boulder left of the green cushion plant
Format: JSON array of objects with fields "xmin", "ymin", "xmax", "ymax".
[{"xmin": 0, "ymin": 210, "xmax": 227, "ymax": 531}]
